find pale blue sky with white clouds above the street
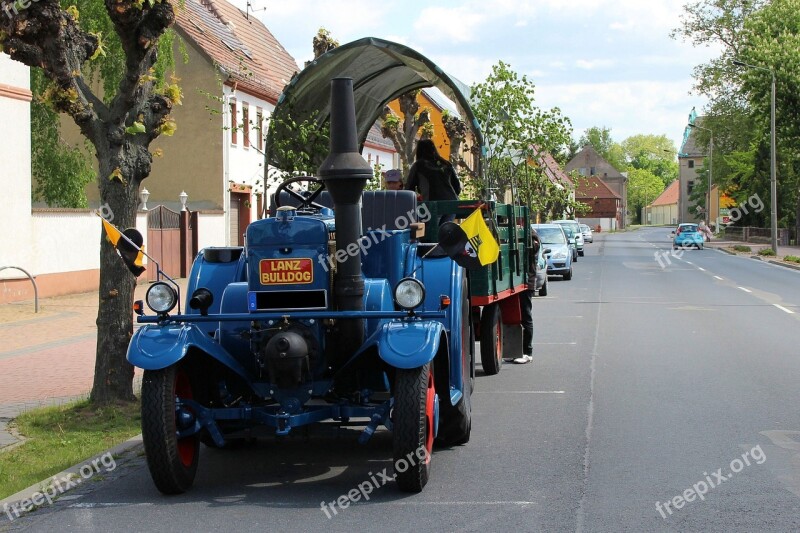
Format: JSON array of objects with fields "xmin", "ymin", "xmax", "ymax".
[{"xmin": 232, "ymin": 0, "xmax": 718, "ymax": 153}]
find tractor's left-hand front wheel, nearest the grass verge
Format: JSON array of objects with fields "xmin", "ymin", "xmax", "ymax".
[{"xmin": 142, "ymin": 365, "xmax": 200, "ymax": 494}]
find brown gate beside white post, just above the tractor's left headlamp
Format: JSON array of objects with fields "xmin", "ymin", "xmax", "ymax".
[{"xmin": 146, "ymin": 205, "xmax": 181, "ymax": 281}]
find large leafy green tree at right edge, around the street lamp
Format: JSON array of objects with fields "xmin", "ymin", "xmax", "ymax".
[{"xmin": 673, "ymin": 0, "xmax": 800, "ymax": 235}]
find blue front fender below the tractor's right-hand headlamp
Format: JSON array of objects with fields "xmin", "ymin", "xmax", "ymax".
[{"xmin": 377, "ymin": 320, "xmax": 444, "ymax": 368}]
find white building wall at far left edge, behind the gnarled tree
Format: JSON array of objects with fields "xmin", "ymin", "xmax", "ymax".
[{"xmin": 0, "ymin": 54, "xmax": 32, "ymax": 279}]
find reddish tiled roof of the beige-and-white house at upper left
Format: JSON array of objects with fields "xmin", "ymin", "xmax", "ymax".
[{"xmin": 176, "ymin": 0, "xmax": 298, "ymax": 103}]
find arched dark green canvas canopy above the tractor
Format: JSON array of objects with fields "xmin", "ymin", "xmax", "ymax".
[{"xmin": 266, "ymin": 37, "xmax": 483, "ymax": 168}]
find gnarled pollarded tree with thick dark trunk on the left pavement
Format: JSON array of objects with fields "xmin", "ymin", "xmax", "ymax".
[{"xmin": 0, "ymin": 0, "xmax": 181, "ymax": 403}]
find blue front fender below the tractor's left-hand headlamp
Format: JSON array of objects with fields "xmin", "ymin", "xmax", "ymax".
[{"xmin": 127, "ymin": 324, "xmax": 250, "ymax": 383}]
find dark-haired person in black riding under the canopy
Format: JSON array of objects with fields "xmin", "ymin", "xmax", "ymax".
[{"xmin": 406, "ymin": 139, "xmax": 461, "ymax": 225}]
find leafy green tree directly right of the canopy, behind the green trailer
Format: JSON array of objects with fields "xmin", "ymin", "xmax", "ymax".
[{"xmin": 471, "ymin": 61, "xmax": 572, "ymax": 205}]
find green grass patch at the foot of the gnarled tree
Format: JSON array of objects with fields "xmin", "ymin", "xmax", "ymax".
[{"xmin": 0, "ymin": 400, "xmax": 141, "ymax": 499}]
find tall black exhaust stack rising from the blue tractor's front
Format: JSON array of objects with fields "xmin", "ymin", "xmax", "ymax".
[{"xmin": 319, "ymin": 78, "xmax": 372, "ymax": 355}]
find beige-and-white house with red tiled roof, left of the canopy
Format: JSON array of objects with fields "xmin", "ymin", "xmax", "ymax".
[{"xmin": 74, "ymin": 0, "xmax": 298, "ymax": 248}]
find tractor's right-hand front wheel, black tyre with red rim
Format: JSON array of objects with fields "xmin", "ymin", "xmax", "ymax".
[{"xmin": 392, "ymin": 363, "xmax": 436, "ymax": 492}]
